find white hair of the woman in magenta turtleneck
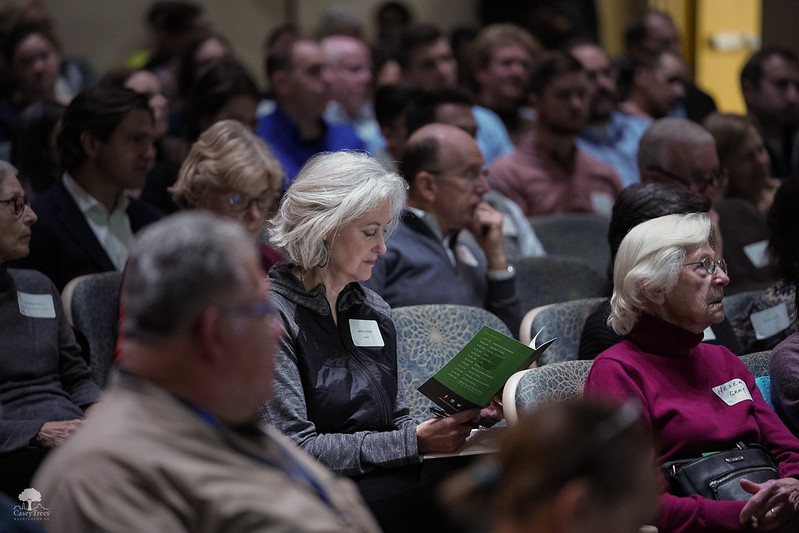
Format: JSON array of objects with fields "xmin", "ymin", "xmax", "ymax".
[{"xmin": 608, "ymin": 213, "xmax": 712, "ymax": 335}]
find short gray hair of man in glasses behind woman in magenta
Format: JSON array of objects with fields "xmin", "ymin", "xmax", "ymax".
[{"xmin": 638, "ymin": 117, "xmax": 714, "ymax": 172}]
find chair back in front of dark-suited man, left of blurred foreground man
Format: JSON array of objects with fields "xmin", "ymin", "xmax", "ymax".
[{"xmin": 61, "ymin": 272, "xmax": 122, "ymax": 387}]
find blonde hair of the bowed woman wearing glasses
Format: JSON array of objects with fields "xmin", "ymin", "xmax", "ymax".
[{"xmin": 169, "ymin": 120, "xmax": 283, "ymax": 209}]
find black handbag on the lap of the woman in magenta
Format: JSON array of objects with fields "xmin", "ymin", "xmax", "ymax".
[{"xmin": 661, "ymin": 442, "xmax": 780, "ymax": 501}]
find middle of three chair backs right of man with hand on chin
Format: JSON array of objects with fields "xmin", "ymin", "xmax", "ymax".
[{"xmin": 514, "ymin": 255, "xmax": 609, "ymax": 311}]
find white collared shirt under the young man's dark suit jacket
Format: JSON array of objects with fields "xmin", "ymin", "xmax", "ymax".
[{"xmin": 63, "ymin": 172, "xmax": 133, "ymax": 271}]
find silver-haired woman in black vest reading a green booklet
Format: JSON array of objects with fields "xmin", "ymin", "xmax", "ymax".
[{"xmin": 263, "ymin": 152, "xmax": 478, "ymax": 530}]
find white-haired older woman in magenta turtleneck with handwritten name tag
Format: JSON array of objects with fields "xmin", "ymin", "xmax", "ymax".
[{"xmin": 585, "ymin": 214, "xmax": 799, "ymax": 533}]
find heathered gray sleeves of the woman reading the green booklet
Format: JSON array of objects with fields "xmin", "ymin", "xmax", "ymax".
[{"xmin": 262, "ymin": 335, "xmax": 421, "ymax": 475}]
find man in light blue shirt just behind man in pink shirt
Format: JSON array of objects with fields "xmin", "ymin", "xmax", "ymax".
[{"xmin": 569, "ymin": 42, "xmax": 652, "ymax": 187}]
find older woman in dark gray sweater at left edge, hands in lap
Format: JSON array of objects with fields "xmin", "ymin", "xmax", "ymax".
[{"xmin": 0, "ymin": 161, "xmax": 100, "ymax": 499}]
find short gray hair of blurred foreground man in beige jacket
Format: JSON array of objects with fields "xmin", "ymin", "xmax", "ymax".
[{"xmin": 122, "ymin": 210, "xmax": 257, "ymax": 340}]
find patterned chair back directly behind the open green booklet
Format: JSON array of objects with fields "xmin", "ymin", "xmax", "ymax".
[{"xmin": 392, "ymin": 304, "xmax": 511, "ymax": 421}]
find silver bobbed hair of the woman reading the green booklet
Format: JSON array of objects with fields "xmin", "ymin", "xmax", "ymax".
[{"xmin": 270, "ymin": 151, "xmax": 408, "ymax": 269}]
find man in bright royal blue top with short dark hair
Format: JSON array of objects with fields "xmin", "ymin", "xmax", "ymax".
[{"xmin": 256, "ymin": 37, "xmax": 366, "ymax": 188}]
